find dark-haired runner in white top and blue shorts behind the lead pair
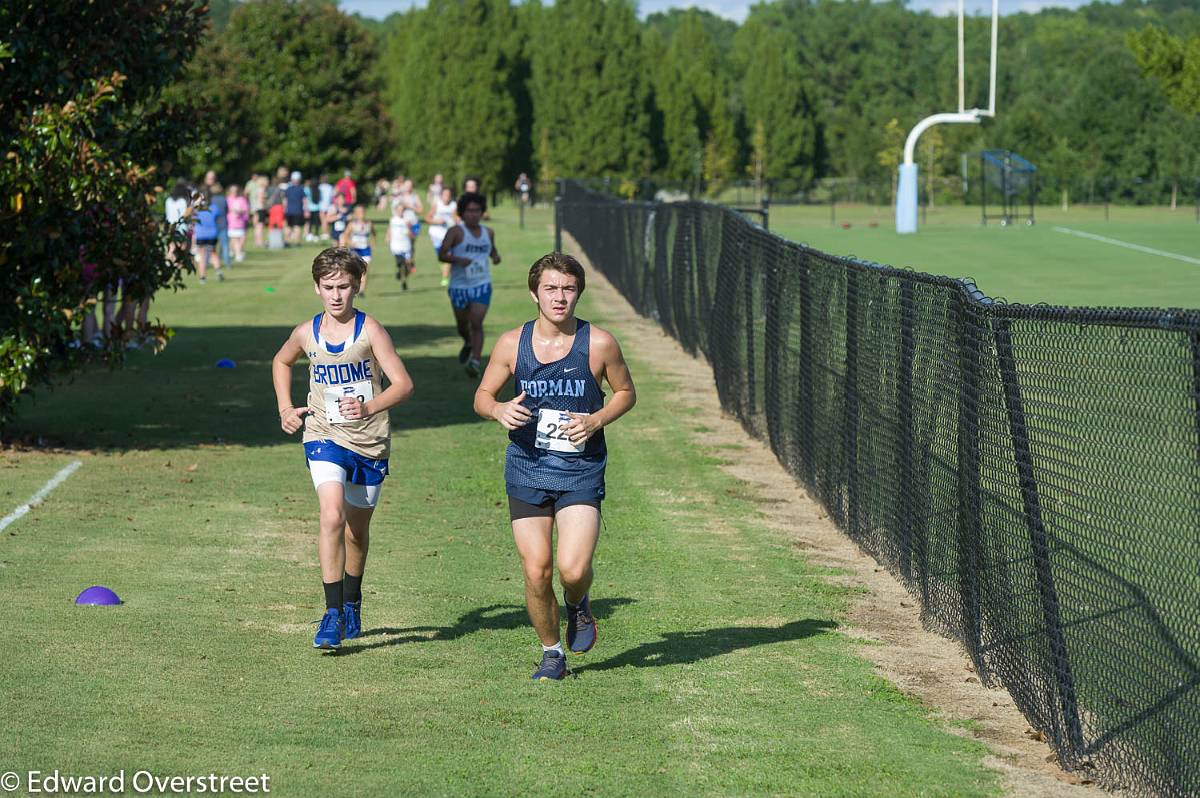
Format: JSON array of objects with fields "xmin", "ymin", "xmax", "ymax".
[{"xmin": 438, "ymin": 192, "xmax": 500, "ymax": 377}]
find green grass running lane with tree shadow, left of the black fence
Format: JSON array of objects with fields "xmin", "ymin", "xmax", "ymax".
[{"xmin": 0, "ymin": 209, "xmax": 1003, "ymax": 796}]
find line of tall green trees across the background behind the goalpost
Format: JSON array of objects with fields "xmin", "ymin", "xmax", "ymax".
[{"xmin": 179, "ymin": 0, "xmax": 1200, "ymax": 202}]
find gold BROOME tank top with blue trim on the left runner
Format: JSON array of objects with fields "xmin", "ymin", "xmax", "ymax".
[{"xmin": 304, "ymin": 311, "xmax": 391, "ymax": 460}]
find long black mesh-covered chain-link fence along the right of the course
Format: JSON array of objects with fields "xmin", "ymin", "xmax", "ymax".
[{"xmin": 558, "ymin": 177, "xmax": 1200, "ymax": 796}]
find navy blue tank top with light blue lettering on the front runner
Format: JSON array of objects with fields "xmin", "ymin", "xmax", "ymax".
[{"xmin": 504, "ymin": 319, "xmax": 608, "ymax": 491}]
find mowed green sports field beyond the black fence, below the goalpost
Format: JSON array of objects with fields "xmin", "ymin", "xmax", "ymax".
[{"xmin": 751, "ymin": 205, "xmax": 1200, "ymax": 308}]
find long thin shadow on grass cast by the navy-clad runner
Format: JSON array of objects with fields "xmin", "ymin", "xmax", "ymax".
[{"xmin": 574, "ymin": 618, "xmax": 838, "ymax": 673}]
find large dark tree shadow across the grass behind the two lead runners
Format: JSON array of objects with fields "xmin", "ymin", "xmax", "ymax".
[{"xmin": 8, "ymin": 321, "xmax": 496, "ymax": 450}]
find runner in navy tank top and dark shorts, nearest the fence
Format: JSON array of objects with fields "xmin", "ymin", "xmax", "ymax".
[{"xmin": 475, "ymin": 252, "xmax": 636, "ymax": 680}]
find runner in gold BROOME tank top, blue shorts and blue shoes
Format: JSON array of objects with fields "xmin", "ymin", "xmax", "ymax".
[{"xmin": 271, "ymin": 248, "xmax": 413, "ymax": 649}]
